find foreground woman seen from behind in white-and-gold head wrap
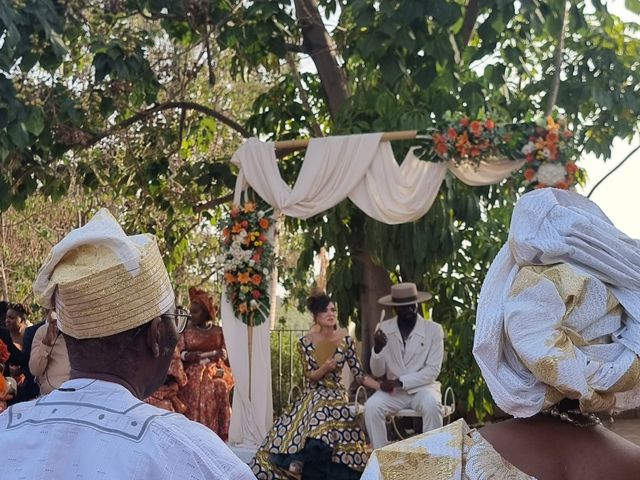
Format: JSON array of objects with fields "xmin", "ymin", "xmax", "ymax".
[{"xmin": 363, "ymin": 189, "xmax": 640, "ymax": 480}]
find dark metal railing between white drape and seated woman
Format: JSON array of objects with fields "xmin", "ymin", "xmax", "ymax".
[{"xmin": 270, "ymin": 329, "xmax": 307, "ymax": 415}]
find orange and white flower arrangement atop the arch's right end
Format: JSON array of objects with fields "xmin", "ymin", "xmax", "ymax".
[{"xmin": 416, "ymin": 117, "xmax": 583, "ymax": 190}]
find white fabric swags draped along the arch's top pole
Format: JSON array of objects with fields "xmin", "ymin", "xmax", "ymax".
[{"xmin": 231, "ymin": 133, "xmax": 523, "ymax": 224}]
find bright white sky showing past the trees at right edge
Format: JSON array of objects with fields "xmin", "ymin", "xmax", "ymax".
[{"xmin": 578, "ymin": 0, "xmax": 640, "ymax": 238}]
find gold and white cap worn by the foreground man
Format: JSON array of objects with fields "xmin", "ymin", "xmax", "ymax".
[{"xmin": 33, "ymin": 208, "xmax": 174, "ymax": 339}]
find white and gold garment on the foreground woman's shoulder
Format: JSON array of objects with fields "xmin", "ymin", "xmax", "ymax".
[{"xmin": 361, "ymin": 419, "xmax": 535, "ymax": 480}]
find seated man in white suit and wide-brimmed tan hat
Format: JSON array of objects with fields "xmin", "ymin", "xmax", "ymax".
[{"xmin": 364, "ymin": 283, "xmax": 444, "ymax": 448}]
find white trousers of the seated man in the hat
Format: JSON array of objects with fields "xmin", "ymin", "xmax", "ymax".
[{"xmin": 364, "ymin": 388, "xmax": 442, "ymax": 448}]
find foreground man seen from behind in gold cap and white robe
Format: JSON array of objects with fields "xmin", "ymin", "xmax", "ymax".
[{"xmin": 0, "ymin": 209, "xmax": 253, "ymax": 480}]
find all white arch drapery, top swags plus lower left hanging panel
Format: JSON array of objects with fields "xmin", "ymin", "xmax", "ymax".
[{"xmin": 221, "ymin": 133, "xmax": 523, "ymax": 446}]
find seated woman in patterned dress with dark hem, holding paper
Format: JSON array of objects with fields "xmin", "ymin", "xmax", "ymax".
[{"xmin": 249, "ymin": 292, "xmax": 379, "ymax": 480}]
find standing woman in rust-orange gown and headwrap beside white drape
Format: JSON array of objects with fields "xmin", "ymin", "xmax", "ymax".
[{"xmin": 178, "ymin": 287, "xmax": 233, "ymax": 441}]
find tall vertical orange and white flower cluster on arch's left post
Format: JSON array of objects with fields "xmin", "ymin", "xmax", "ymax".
[{"xmin": 220, "ymin": 202, "xmax": 274, "ymax": 326}]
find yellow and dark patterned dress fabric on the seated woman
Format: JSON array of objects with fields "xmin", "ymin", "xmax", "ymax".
[{"xmin": 249, "ymin": 336, "xmax": 371, "ymax": 480}]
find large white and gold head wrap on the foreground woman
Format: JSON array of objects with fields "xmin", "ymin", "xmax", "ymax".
[{"xmin": 473, "ymin": 188, "xmax": 640, "ymax": 417}]
